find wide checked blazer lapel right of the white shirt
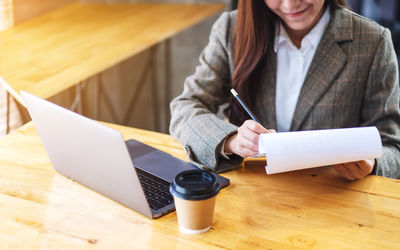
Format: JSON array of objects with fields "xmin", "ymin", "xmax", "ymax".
[{"xmin": 290, "ymin": 9, "xmax": 352, "ymax": 131}]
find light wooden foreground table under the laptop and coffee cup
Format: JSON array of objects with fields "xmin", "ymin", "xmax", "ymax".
[{"xmin": 0, "ymin": 123, "xmax": 400, "ymax": 249}]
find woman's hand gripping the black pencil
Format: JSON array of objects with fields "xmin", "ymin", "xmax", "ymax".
[{"xmin": 224, "ymin": 120, "xmax": 275, "ymax": 158}]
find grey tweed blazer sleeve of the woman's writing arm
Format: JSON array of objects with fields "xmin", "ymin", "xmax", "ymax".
[{"xmin": 169, "ymin": 12, "xmax": 243, "ymax": 172}]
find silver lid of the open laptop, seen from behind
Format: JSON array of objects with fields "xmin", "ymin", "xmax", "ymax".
[{"xmin": 21, "ymin": 91, "xmax": 152, "ymax": 218}]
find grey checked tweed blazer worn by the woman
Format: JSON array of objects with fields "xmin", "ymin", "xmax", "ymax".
[{"xmin": 170, "ymin": 9, "xmax": 400, "ymax": 178}]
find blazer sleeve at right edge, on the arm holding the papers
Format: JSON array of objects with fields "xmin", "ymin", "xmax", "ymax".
[{"xmin": 361, "ymin": 29, "xmax": 400, "ymax": 179}]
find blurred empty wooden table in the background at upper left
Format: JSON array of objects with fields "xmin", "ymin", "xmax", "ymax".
[{"xmin": 0, "ymin": 2, "xmax": 224, "ymax": 130}]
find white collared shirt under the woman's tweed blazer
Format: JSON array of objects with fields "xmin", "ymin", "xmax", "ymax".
[{"xmin": 274, "ymin": 7, "xmax": 330, "ymax": 132}]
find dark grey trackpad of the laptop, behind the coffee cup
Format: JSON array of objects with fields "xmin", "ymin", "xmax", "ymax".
[{"xmin": 133, "ymin": 150, "xmax": 198, "ymax": 183}]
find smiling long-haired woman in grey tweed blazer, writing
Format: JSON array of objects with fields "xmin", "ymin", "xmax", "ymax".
[{"xmin": 170, "ymin": 0, "xmax": 400, "ymax": 180}]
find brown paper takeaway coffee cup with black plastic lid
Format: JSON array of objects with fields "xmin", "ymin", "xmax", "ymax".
[{"xmin": 170, "ymin": 170, "xmax": 220, "ymax": 234}]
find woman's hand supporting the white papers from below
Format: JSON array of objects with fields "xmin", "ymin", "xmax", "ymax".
[{"xmin": 333, "ymin": 159, "xmax": 375, "ymax": 181}]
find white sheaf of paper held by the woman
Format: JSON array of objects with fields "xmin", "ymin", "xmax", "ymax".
[{"xmin": 259, "ymin": 127, "xmax": 382, "ymax": 174}]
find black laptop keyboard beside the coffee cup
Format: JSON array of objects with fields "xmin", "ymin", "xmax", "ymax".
[{"xmin": 135, "ymin": 168, "xmax": 174, "ymax": 210}]
